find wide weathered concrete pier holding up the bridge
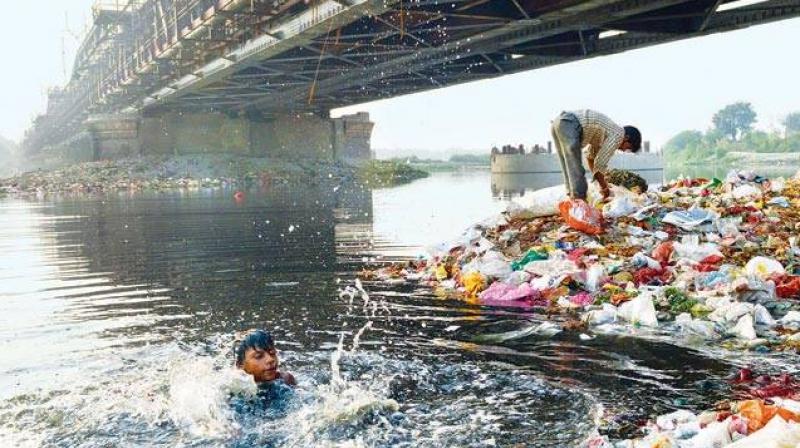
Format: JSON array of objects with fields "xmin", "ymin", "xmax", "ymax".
[{"xmin": 86, "ymin": 111, "xmax": 374, "ymax": 163}]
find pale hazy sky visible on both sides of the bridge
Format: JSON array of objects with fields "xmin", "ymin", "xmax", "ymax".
[{"xmin": 0, "ymin": 0, "xmax": 800, "ymax": 154}]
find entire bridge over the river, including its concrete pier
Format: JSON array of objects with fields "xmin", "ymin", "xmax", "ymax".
[{"xmin": 24, "ymin": 0, "xmax": 800, "ymax": 163}]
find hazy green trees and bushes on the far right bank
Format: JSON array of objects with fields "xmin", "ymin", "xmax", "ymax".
[{"xmin": 664, "ymin": 102, "xmax": 800, "ymax": 165}]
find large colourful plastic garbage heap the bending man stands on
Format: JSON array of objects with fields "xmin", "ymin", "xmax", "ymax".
[{"xmin": 368, "ymin": 171, "xmax": 800, "ymax": 352}]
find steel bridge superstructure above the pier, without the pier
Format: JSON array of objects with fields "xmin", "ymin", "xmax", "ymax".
[{"xmin": 21, "ymin": 0, "xmax": 800, "ymax": 152}]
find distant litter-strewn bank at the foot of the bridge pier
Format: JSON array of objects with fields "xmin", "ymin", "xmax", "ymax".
[{"xmin": 0, "ymin": 154, "xmax": 427, "ymax": 195}]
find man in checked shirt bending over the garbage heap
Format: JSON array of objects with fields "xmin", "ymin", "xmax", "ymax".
[{"xmin": 551, "ymin": 109, "xmax": 642, "ymax": 200}]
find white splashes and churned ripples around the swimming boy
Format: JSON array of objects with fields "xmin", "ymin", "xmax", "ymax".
[{"xmin": 0, "ymin": 328, "xmax": 595, "ymax": 447}]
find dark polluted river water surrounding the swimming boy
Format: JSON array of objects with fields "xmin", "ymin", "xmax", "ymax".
[{"xmin": 0, "ymin": 172, "xmax": 788, "ymax": 447}]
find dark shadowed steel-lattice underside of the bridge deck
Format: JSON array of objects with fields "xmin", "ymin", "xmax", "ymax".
[{"xmin": 155, "ymin": 0, "xmax": 800, "ymax": 114}]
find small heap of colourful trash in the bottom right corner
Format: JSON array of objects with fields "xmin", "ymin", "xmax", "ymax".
[{"xmin": 586, "ymin": 369, "xmax": 800, "ymax": 448}]
